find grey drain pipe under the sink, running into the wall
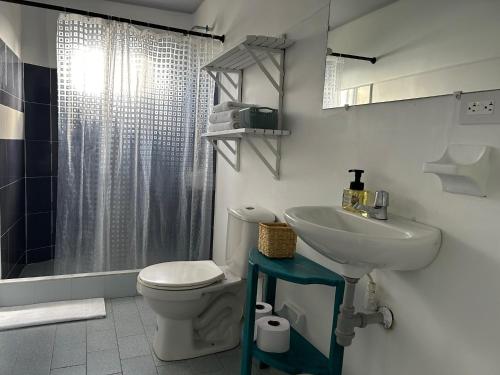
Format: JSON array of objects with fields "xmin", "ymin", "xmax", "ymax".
[{"xmin": 335, "ymin": 277, "xmax": 393, "ymax": 346}]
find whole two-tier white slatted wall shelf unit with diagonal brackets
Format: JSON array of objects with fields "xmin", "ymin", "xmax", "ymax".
[{"xmin": 203, "ymin": 35, "xmax": 293, "ymax": 179}]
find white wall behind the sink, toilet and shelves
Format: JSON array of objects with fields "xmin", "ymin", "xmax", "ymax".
[{"xmin": 195, "ymin": 0, "xmax": 500, "ymax": 375}]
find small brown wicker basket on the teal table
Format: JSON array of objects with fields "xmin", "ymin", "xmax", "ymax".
[{"xmin": 259, "ymin": 223, "xmax": 297, "ymax": 258}]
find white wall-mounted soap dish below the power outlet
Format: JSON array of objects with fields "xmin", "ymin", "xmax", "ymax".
[{"xmin": 424, "ymin": 144, "xmax": 491, "ymax": 197}]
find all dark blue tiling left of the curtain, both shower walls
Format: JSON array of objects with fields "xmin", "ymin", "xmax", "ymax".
[{"xmin": 0, "ymin": 39, "xmax": 58, "ymax": 278}]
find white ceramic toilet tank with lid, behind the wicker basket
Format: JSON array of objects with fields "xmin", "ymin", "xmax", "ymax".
[{"xmin": 226, "ymin": 206, "xmax": 276, "ymax": 279}]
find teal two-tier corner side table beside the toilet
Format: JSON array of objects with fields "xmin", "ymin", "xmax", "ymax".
[{"xmin": 241, "ymin": 249, "xmax": 344, "ymax": 375}]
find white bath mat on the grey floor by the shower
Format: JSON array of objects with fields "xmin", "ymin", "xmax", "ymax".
[{"xmin": 0, "ymin": 298, "xmax": 106, "ymax": 331}]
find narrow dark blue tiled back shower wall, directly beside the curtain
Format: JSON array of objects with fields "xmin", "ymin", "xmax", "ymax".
[{"xmin": 24, "ymin": 64, "xmax": 59, "ymax": 263}]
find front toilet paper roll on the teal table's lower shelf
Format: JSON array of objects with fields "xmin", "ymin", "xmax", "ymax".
[{"xmin": 255, "ymin": 316, "xmax": 290, "ymax": 353}]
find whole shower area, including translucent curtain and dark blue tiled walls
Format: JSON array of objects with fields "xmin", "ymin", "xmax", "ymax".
[{"xmin": 0, "ymin": 1, "xmax": 222, "ymax": 279}]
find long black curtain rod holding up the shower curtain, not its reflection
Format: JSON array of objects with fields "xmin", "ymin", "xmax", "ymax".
[{"xmin": 0, "ymin": 0, "xmax": 225, "ymax": 43}]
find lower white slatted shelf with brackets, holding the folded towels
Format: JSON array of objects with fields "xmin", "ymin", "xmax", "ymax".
[{"xmin": 201, "ymin": 128, "xmax": 290, "ymax": 179}]
